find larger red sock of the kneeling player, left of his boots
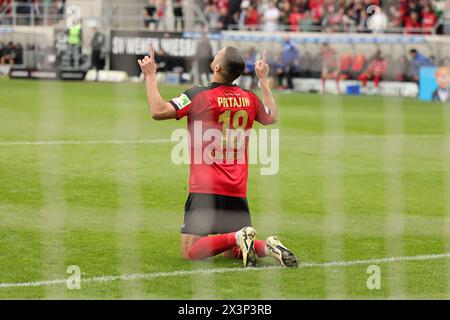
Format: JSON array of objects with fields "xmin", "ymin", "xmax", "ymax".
[{"xmin": 189, "ymin": 232, "xmax": 236, "ymax": 260}]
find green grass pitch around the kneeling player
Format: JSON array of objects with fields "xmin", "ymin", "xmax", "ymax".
[{"xmin": 0, "ymin": 79, "xmax": 450, "ymax": 299}]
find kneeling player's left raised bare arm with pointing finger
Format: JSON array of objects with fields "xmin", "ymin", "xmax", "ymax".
[{"xmin": 138, "ymin": 47, "xmax": 176, "ymax": 120}]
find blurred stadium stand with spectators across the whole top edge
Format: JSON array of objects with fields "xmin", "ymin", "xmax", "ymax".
[{"xmin": 0, "ymin": 0, "xmax": 445, "ymax": 34}]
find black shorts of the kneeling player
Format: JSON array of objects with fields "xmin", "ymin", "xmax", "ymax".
[{"xmin": 181, "ymin": 193, "xmax": 252, "ymax": 236}]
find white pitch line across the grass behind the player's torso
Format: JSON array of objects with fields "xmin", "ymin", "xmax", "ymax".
[{"xmin": 0, "ymin": 134, "xmax": 447, "ymax": 146}]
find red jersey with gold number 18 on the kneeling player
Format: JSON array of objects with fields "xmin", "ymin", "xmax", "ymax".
[{"xmin": 170, "ymin": 83, "xmax": 273, "ymax": 197}]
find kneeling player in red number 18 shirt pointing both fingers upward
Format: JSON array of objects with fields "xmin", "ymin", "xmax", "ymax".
[{"xmin": 138, "ymin": 43, "xmax": 297, "ymax": 267}]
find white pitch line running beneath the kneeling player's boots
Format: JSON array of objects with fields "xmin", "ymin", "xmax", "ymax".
[{"xmin": 0, "ymin": 252, "xmax": 450, "ymax": 288}]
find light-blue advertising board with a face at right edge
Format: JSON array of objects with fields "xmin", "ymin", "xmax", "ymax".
[{"xmin": 419, "ymin": 67, "xmax": 450, "ymax": 102}]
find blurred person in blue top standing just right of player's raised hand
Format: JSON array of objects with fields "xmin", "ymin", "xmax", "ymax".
[{"xmin": 277, "ymin": 36, "xmax": 300, "ymax": 91}]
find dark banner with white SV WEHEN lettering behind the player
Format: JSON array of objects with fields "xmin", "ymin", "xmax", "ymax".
[{"xmin": 111, "ymin": 30, "xmax": 216, "ymax": 76}]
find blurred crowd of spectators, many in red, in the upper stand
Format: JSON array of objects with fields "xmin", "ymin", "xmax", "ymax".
[{"xmin": 144, "ymin": 0, "xmax": 445, "ymax": 34}]
